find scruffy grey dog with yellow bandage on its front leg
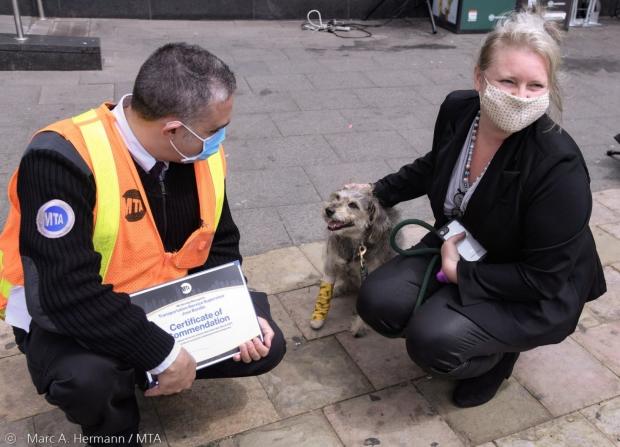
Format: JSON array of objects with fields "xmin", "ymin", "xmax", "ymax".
[{"xmin": 310, "ymin": 185, "xmax": 399, "ymax": 337}]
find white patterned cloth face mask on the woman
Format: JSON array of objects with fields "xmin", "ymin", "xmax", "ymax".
[{"xmin": 480, "ymin": 78, "xmax": 549, "ymax": 134}]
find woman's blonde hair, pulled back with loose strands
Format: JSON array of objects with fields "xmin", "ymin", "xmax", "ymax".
[{"xmin": 476, "ymin": 8, "xmax": 563, "ymax": 121}]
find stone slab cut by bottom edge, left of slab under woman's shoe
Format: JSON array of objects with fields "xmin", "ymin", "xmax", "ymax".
[{"xmin": 325, "ymin": 385, "xmax": 464, "ymax": 447}]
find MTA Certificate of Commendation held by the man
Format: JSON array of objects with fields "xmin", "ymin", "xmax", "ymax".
[{"xmin": 131, "ymin": 262, "xmax": 262, "ymax": 369}]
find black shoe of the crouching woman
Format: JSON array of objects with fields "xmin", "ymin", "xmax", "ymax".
[{"xmin": 452, "ymin": 352, "xmax": 519, "ymax": 408}]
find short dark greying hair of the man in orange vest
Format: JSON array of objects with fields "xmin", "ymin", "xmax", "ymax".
[{"xmin": 131, "ymin": 43, "xmax": 237, "ymax": 121}]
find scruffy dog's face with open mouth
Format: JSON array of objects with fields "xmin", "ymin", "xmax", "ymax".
[{"xmin": 323, "ymin": 188, "xmax": 385, "ymax": 239}]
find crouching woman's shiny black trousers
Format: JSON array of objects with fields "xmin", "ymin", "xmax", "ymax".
[{"xmin": 357, "ymin": 250, "xmax": 522, "ymax": 379}]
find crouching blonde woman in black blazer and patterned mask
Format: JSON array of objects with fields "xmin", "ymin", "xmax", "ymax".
[{"xmin": 358, "ymin": 12, "xmax": 606, "ymax": 407}]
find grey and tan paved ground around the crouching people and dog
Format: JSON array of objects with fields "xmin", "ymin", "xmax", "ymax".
[{"xmin": 0, "ymin": 16, "xmax": 620, "ymax": 447}]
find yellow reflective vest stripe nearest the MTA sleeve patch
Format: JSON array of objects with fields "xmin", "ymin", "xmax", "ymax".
[{"xmin": 73, "ymin": 110, "xmax": 121, "ymax": 278}]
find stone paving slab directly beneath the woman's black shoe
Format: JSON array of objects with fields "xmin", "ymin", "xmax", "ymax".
[{"xmin": 416, "ymin": 378, "xmax": 552, "ymax": 445}]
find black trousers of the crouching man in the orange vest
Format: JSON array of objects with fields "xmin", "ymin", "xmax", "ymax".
[{"xmin": 16, "ymin": 292, "xmax": 286, "ymax": 446}]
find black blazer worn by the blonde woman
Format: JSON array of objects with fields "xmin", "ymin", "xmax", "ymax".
[{"xmin": 374, "ymin": 90, "xmax": 606, "ymax": 347}]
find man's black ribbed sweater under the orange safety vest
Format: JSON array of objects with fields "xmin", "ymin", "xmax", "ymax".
[{"xmin": 17, "ymin": 132, "xmax": 241, "ymax": 371}]
